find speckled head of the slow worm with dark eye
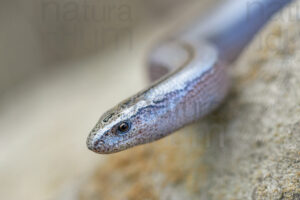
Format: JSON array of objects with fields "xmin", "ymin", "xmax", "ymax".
[{"xmin": 87, "ymin": 97, "xmax": 159, "ymax": 154}]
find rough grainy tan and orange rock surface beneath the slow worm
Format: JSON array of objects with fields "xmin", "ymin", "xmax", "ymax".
[{"xmin": 78, "ymin": 1, "xmax": 300, "ymax": 200}]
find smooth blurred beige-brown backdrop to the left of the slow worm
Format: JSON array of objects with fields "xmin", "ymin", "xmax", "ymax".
[{"xmin": 0, "ymin": 0, "xmax": 213, "ymax": 200}]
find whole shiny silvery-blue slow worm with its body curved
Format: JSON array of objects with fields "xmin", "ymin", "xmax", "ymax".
[{"xmin": 87, "ymin": 0, "xmax": 292, "ymax": 154}]
